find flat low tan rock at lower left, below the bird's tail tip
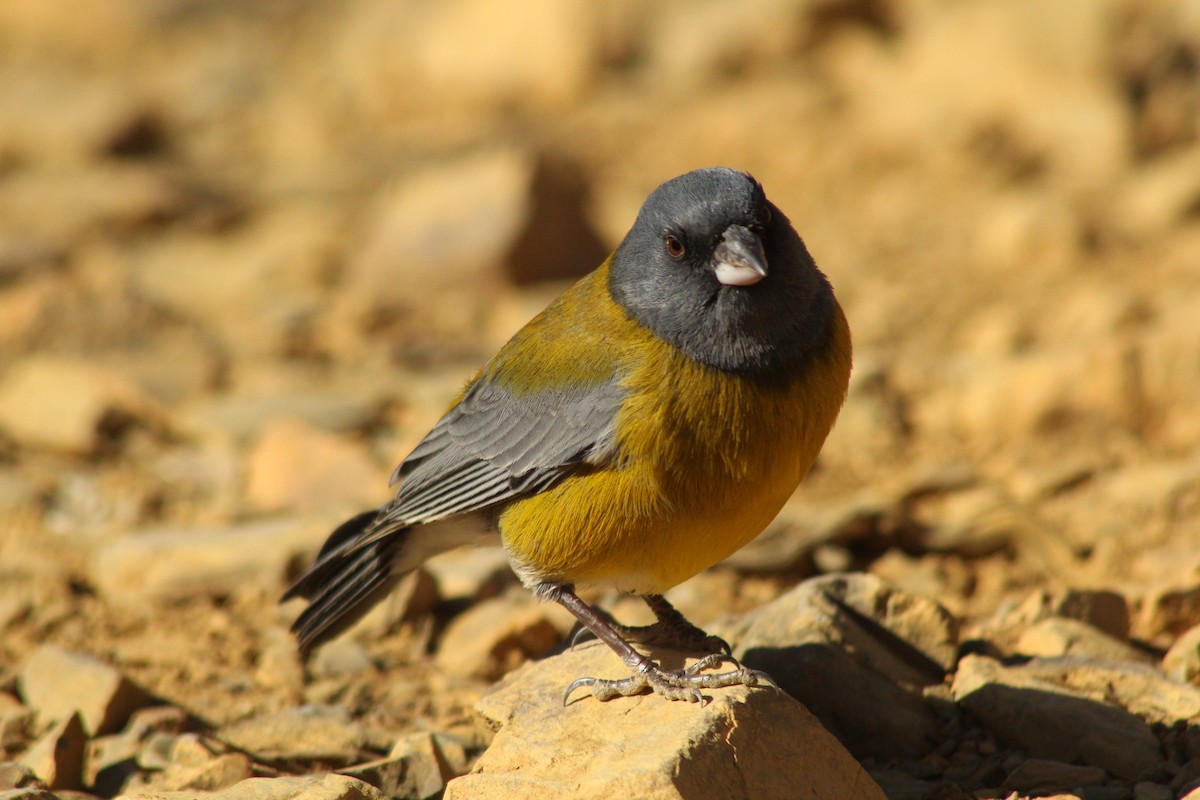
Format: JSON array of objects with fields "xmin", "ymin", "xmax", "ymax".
[{"xmin": 220, "ymin": 705, "xmax": 366, "ymax": 764}]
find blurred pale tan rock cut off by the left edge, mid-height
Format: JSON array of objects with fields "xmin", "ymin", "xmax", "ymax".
[{"xmin": 0, "ymin": 356, "xmax": 173, "ymax": 455}]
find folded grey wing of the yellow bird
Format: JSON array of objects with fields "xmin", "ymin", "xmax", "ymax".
[{"xmin": 356, "ymin": 379, "xmax": 624, "ymax": 537}]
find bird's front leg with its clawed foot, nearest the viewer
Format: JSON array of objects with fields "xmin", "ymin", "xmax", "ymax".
[{"xmin": 538, "ymin": 584, "xmax": 775, "ymax": 704}]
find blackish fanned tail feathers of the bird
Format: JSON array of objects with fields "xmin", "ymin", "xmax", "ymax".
[{"xmin": 282, "ymin": 510, "xmax": 408, "ymax": 652}]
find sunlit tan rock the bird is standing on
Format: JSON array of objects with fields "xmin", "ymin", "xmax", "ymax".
[{"xmin": 445, "ymin": 645, "xmax": 883, "ymax": 800}]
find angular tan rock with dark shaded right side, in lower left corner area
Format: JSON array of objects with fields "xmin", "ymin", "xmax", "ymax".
[{"xmin": 20, "ymin": 644, "xmax": 151, "ymax": 735}]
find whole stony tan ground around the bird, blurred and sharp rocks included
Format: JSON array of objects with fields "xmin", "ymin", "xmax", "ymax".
[{"xmin": 0, "ymin": 0, "xmax": 1200, "ymax": 800}]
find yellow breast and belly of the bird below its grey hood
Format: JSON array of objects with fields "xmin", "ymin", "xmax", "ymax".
[{"xmin": 499, "ymin": 303, "xmax": 851, "ymax": 593}]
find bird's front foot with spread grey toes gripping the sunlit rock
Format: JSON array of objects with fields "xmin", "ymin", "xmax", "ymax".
[{"xmin": 563, "ymin": 652, "xmax": 779, "ymax": 705}]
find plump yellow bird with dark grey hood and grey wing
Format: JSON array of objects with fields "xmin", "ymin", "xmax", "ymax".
[{"xmin": 283, "ymin": 167, "xmax": 852, "ymax": 704}]
